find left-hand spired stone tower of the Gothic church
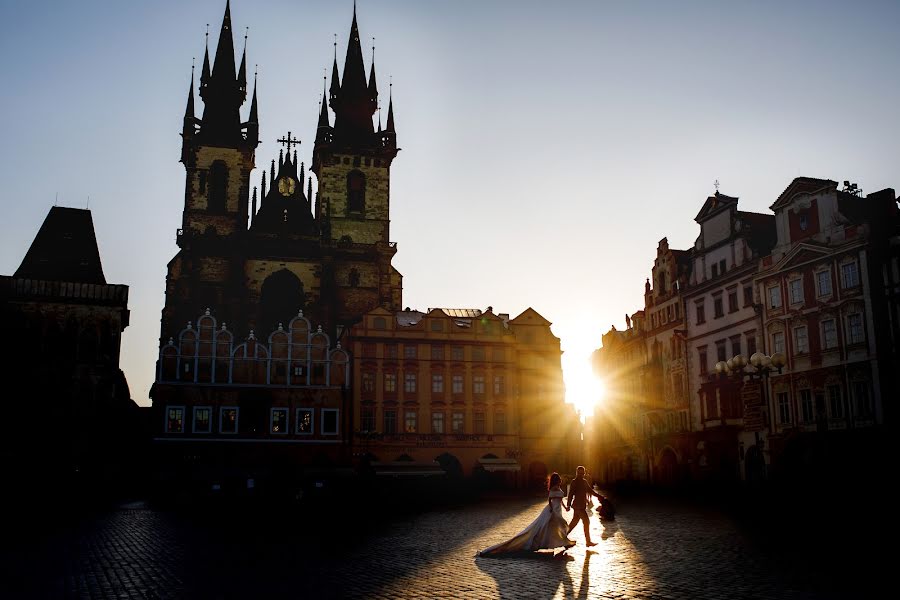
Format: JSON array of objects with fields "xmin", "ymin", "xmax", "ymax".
[{"xmin": 161, "ymin": 2, "xmax": 259, "ymax": 339}]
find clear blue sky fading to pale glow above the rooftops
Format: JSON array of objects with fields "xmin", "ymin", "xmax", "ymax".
[{"xmin": 0, "ymin": 0, "xmax": 900, "ymax": 412}]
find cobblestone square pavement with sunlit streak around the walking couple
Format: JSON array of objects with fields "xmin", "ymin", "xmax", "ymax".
[{"xmin": 0, "ymin": 499, "xmax": 867, "ymax": 599}]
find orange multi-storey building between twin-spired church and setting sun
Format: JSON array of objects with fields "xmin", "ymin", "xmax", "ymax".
[{"xmin": 344, "ymin": 307, "xmax": 578, "ymax": 485}]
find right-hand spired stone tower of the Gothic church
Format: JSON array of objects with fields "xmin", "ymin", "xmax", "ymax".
[{"xmin": 312, "ymin": 5, "xmax": 402, "ymax": 310}]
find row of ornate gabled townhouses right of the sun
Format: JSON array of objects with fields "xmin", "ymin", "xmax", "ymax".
[{"xmin": 587, "ymin": 177, "xmax": 900, "ymax": 484}]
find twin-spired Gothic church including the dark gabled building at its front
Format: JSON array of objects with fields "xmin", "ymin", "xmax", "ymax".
[{"xmin": 151, "ymin": 5, "xmax": 402, "ymax": 488}]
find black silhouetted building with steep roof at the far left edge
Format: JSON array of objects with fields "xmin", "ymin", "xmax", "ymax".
[{"xmin": 0, "ymin": 206, "xmax": 139, "ymax": 497}]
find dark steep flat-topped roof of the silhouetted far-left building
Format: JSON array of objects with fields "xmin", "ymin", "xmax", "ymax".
[{"xmin": 15, "ymin": 206, "xmax": 106, "ymax": 285}]
